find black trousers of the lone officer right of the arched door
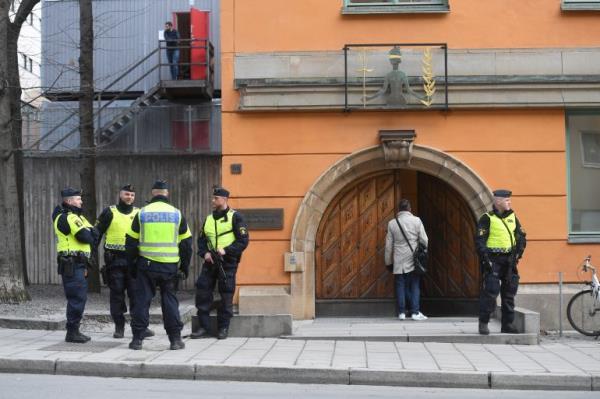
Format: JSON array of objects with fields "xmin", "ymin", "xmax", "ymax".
[{"xmin": 479, "ymin": 255, "xmax": 519, "ymax": 326}]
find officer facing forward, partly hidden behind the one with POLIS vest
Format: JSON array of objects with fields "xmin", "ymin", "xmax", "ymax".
[{"xmin": 96, "ymin": 184, "xmax": 154, "ymax": 338}]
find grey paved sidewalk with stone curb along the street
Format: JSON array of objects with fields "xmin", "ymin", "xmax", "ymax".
[{"xmin": 0, "ymin": 325, "xmax": 600, "ymax": 391}]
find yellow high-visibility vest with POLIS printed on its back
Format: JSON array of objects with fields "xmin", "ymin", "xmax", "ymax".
[{"xmin": 139, "ymin": 201, "xmax": 181, "ymax": 263}]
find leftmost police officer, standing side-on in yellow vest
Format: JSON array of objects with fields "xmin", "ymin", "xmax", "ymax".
[{"xmin": 52, "ymin": 187, "xmax": 97, "ymax": 344}]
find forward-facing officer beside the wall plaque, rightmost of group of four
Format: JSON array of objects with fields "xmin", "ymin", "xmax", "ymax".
[{"xmin": 190, "ymin": 187, "xmax": 248, "ymax": 339}]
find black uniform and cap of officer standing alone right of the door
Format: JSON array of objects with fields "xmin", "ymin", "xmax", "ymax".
[{"xmin": 475, "ymin": 190, "xmax": 526, "ymax": 334}]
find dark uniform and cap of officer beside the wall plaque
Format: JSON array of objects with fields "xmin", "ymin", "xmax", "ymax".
[{"xmin": 191, "ymin": 189, "xmax": 249, "ymax": 339}]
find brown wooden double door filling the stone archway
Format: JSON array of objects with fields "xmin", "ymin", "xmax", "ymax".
[{"xmin": 316, "ymin": 170, "xmax": 480, "ymax": 300}]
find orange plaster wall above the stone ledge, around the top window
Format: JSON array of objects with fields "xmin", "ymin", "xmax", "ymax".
[{"xmin": 221, "ymin": 0, "xmax": 600, "ymax": 52}]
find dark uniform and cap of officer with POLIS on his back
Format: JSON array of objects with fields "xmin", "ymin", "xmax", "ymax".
[{"xmin": 125, "ymin": 188, "xmax": 192, "ymax": 349}]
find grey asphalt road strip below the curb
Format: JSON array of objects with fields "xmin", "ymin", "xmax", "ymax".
[{"xmin": 0, "ymin": 374, "xmax": 598, "ymax": 399}]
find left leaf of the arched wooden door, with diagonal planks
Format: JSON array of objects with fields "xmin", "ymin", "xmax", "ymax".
[{"xmin": 316, "ymin": 172, "xmax": 401, "ymax": 299}]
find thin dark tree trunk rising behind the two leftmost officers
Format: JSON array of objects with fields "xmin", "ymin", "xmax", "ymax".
[{"xmin": 79, "ymin": 0, "xmax": 100, "ymax": 292}]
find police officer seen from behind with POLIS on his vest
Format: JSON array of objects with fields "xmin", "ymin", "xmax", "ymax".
[{"xmin": 125, "ymin": 180, "xmax": 192, "ymax": 350}]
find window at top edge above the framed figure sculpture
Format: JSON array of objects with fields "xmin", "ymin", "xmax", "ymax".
[{"xmin": 342, "ymin": 0, "xmax": 450, "ymax": 14}]
